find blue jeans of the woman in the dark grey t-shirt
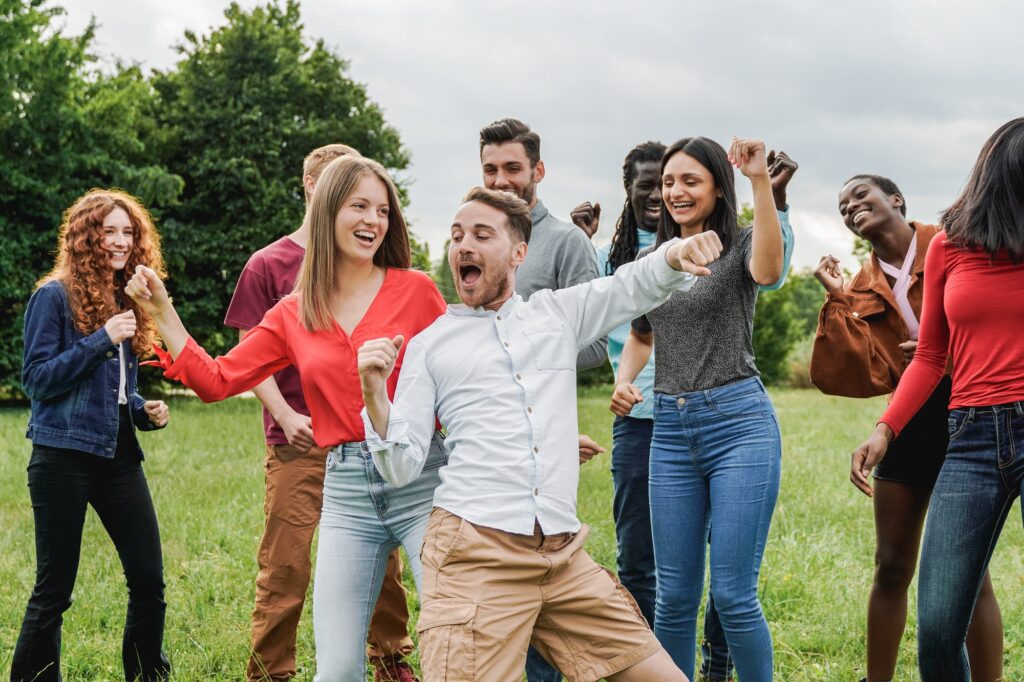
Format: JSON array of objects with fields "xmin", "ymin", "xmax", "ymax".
[{"xmin": 650, "ymin": 377, "xmax": 782, "ymax": 682}]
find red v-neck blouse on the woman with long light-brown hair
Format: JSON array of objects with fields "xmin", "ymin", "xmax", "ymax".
[{"xmin": 162, "ymin": 268, "xmax": 445, "ymax": 447}]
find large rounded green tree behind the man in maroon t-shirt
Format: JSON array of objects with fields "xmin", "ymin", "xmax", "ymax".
[{"xmin": 153, "ymin": 0, "xmax": 411, "ymax": 352}]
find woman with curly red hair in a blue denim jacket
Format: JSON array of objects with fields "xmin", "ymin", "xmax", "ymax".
[{"xmin": 11, "ymin": 189, "xmax": 170, "ymax": 682}]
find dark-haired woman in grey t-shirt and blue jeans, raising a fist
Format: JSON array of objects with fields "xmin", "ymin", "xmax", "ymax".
[{"xmin": 612, "ymin": 137, "xmax": 783, "ymax": 681}]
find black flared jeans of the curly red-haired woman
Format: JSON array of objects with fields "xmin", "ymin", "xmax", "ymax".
[{"xmin": 10, "ymin": 422, "xmax": 170, "ymax": 682}]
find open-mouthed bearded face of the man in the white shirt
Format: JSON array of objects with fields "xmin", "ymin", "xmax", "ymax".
[{"xmin": 449, "ymin": 202, "xmax": 526, "ymax": 310}]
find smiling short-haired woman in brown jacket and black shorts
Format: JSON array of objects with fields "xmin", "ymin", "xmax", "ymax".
[{"xmin": 811, "ymin": 175, "xmax": 1002, "ymax": 682}]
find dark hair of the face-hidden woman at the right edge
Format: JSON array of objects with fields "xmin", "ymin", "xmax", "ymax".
[{"xmin": 942, "ymin": 118, "xmax": 1024, "ymax": 260}]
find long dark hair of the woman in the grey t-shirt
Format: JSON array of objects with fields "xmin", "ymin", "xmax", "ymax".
[{"xmin": 657, "ymin": 137, "xmax": 739, "ymax": 253}]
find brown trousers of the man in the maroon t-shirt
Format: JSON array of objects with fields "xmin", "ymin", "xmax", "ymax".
[{"xmin": 246, "ymin": 445, "xmax": 413, "ymax": 681}]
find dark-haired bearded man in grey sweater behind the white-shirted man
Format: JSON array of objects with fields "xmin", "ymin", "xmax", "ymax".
[{"xmin": 480, "ymin": 119, "xmax": 608, "ymax": 368}]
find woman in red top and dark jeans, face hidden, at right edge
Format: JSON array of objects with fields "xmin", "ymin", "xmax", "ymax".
[{"xmin": 852, "ymin": 118, "xmax": 1024, "ymax": 682}]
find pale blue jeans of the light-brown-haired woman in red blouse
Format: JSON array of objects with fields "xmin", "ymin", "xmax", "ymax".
[{"xmin": 313, "ymin": 433, "xmax": 447, "ymax": 682}]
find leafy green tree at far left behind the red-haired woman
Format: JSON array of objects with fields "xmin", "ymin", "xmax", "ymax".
[{"xmin": 0, "ymin": 0, "xmax": 181, "ymax": 395}]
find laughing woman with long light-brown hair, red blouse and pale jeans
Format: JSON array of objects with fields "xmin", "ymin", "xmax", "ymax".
[{"xmin": 126, "ymin": 156, "xmax": 446, "ymax": 680}]
